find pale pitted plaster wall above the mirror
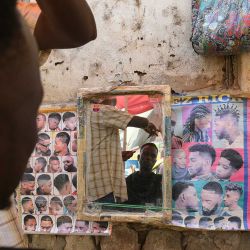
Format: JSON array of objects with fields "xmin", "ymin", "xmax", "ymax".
[{"xmin": 41, "ymin": 0, "xmax": 227, "ymax": 102}]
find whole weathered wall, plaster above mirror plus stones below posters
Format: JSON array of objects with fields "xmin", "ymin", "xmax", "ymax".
[{"xmin": 33, "ymin": 0, "xmax": 250, "ymax": 250}]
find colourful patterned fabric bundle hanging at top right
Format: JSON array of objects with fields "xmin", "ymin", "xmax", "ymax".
[{"xmin": 191, "ymin": 0, "xmax": 250, "ymax": 55}]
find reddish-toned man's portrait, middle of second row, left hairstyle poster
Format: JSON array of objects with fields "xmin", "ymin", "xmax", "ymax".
[{"xmin": 54, "ymin": 132, "xmax": 70, "ymax": 156}]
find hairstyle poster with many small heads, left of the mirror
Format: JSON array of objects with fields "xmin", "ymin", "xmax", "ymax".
[{"xmin": 19, "ymin": 108, "xmax": 111, "ymax": 235}]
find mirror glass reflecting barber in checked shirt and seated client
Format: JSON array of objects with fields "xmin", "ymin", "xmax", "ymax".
[{"xmin": 85, "ymin": 94, "xmax": 164, "ymax": 212}]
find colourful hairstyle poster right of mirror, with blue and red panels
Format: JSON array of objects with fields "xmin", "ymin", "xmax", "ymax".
[{"xmin": 171, "ymin": 95, "xmax": 245, "ymax": 230}]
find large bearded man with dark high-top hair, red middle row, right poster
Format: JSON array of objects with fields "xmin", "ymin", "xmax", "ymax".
[{"xmin": 188, "ymin": 143, "xmax": 216, "ymax": 181}]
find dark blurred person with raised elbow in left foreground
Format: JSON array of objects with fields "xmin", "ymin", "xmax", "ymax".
[{"xmin": 0, "ymin": 0, "xmax": 96, "ymax": 247}]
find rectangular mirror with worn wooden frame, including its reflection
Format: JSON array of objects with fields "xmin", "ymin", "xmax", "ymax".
[{"xmin": 78, "ymin": 86, "xmax": 171, "ymax": 224}]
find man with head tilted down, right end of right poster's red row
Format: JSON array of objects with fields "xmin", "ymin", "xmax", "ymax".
[{"xmin": 215, "ymin": 149, "xmax": 243, "ymax": 181}]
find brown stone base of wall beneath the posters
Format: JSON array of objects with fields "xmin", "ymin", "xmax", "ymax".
[{"xmin": 26, "ymin": 225, "xmax": 250, "ymax": 250}]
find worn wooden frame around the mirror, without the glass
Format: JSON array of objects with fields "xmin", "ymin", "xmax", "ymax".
[{"xmin": 77, "ymin": 85, "xmax": 172, "ymax": 225}]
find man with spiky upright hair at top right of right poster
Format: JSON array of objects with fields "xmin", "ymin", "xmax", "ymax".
[{"xmin": 214, "ymin": 104, "xmax": 244, "ymax": 148}]
